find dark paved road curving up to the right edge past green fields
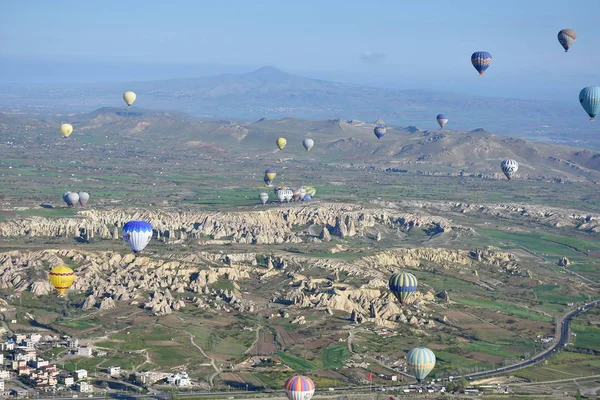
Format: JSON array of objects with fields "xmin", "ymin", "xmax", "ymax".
[{"xmin": 452, "ymin": 300, "xmax": 600, "ymax": 380}]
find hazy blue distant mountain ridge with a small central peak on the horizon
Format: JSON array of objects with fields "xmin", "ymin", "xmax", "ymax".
[{"xmin": 0, "ymin": 67, "xmax": 600, "ymax": 148}]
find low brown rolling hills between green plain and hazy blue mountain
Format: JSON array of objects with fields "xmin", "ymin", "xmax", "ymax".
[{"xmin": 0, "ymin": 108, "xmax": 600, "ymax": 182}]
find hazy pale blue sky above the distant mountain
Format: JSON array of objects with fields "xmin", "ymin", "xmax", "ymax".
[{"xmin": 0, "ymin": 0, "xmax": 600, "ymax": 99}]
